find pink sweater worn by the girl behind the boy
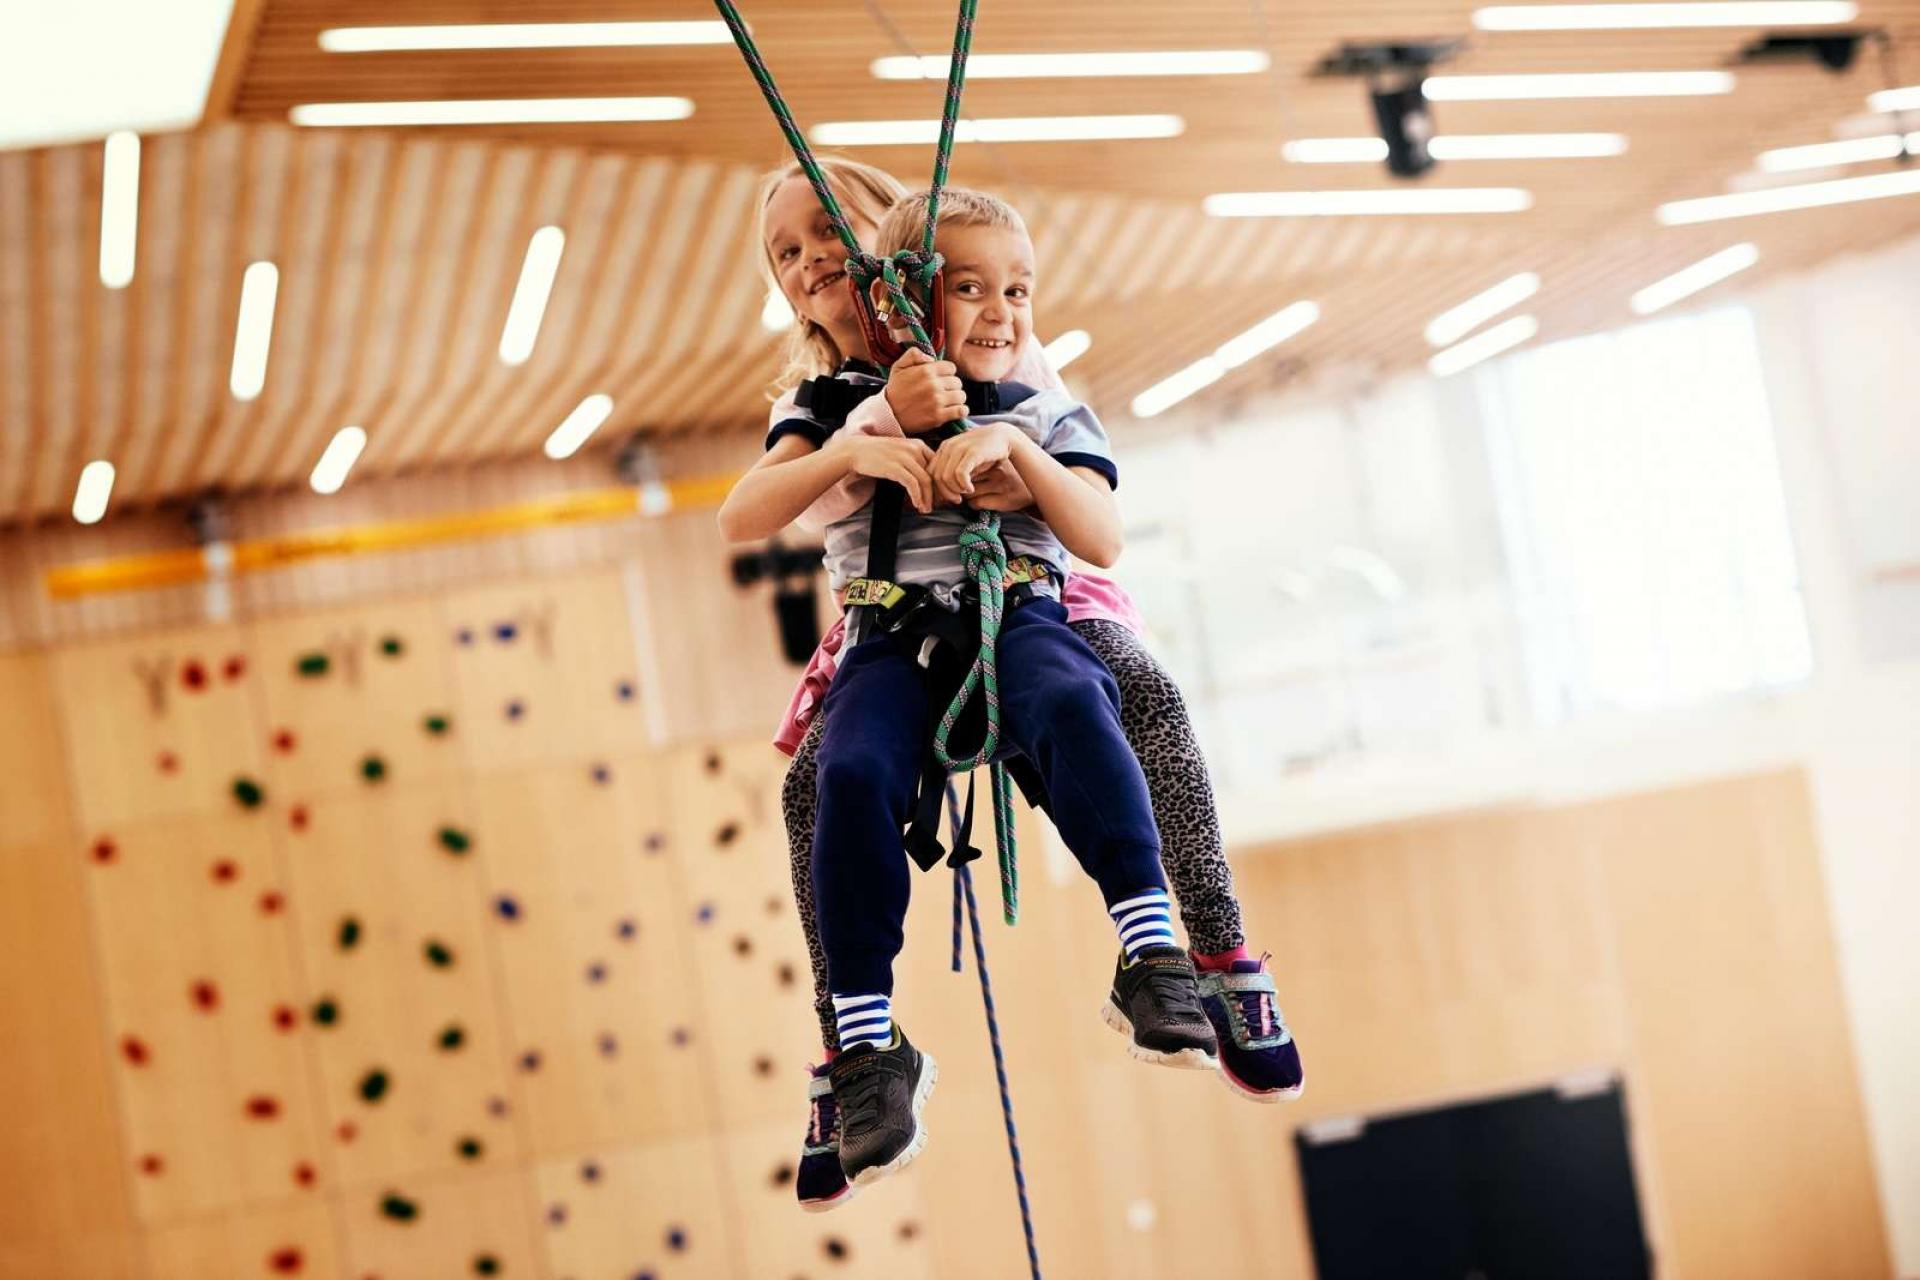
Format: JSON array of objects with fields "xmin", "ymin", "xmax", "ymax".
[{"xmin": 768, "ymin": 344, "xmax": 1144, "ymax": 756}]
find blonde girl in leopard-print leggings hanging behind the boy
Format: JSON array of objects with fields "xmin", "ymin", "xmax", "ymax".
[{"xmin": 722, "ymin": 157, "xmax": 1302, "ymax": 1209}]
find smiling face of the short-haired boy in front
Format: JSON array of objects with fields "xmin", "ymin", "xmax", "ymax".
[{"xmin": 935, "ymin": 225, "xmax": 1033, "ymax": 382}]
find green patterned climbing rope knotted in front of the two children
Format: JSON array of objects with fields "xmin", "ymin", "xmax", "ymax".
[{"xmin": 714, "ymin": 0, "xmax": 1020, "ymax": 925}]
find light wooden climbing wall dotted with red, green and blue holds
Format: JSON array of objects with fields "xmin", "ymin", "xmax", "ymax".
[{"xmin": 37, "ymin": 574, "xmax": 931, "ymax": 1280}]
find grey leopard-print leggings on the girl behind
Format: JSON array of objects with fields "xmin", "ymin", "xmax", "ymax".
[{"xmin": 780, "ymin": 620, "xmax": 1246, "ymax": 1048}]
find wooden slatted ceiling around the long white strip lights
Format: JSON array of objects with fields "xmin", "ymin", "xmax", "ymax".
[{"xmin": 0, "ymin": 0, "xmax": 1920, "ymax": 522}]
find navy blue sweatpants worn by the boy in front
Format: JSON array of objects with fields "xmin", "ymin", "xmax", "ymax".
[{"xmin": 814, "ymin": 601, "xmax": 1167, "ymax": 994}]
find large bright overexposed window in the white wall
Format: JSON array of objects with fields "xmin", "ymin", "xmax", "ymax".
[{"xmin": 1478, "ymin": 307, "xmax": 1811, "ymax": 723}]
